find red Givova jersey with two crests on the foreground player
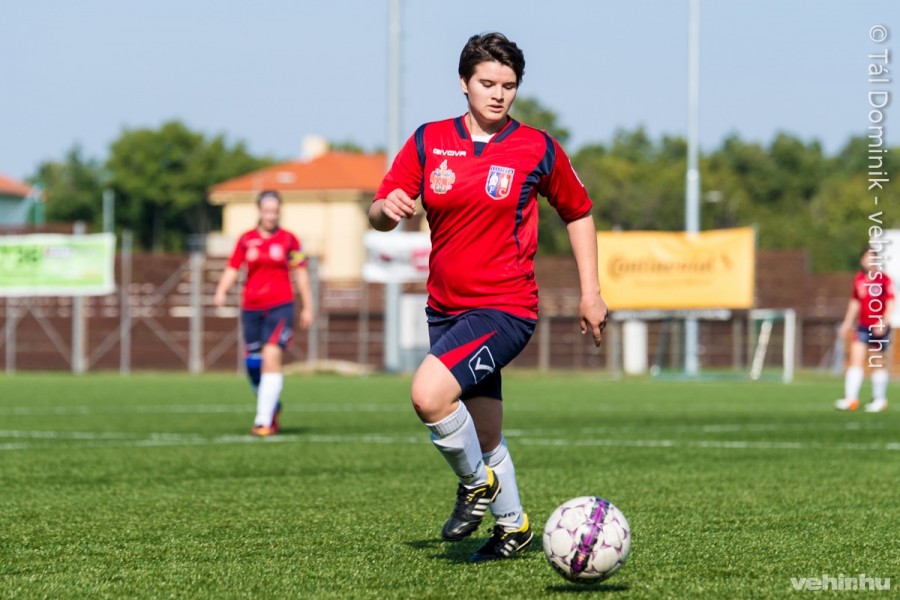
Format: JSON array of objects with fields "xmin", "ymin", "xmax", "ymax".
[{"xmin": 375, "ymin": 117, "xmax": 591, "ymax": 319}]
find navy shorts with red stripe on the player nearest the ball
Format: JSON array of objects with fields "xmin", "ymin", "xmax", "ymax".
[{"xmin": 425, "ymin": 308, "xmax": 537, "ymax": 400}]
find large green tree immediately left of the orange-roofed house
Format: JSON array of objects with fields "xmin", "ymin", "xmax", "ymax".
[{"xmin": 106, "ymin": 121, "xmax": 272, "ymax": 252}]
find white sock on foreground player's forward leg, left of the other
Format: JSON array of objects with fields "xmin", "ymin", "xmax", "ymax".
[{"xmin": 425, "ymin": 402, "xmax": 487, "ymax": 485}]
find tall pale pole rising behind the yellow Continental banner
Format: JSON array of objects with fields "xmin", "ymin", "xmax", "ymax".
[{"xmin": 684, "ymin": 0, "xmax": 700, "ymax": 375}]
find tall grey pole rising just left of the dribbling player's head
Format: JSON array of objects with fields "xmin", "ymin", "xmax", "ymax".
[{"xmin": 384, "ymin": 0, "xmax": 403, "ymax": 371}]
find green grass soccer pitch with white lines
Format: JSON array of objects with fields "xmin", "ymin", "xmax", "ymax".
[{"xmin": 0, "ymin": 371, "xmax": 900, "ymax": 600}]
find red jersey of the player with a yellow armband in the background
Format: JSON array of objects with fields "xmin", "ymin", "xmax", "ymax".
[{"xmin": 228, "ymin": 229, "xmax": 306, "ymax": 310}]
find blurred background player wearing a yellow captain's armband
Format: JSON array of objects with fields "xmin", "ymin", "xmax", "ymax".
[{"xmin": 214, "ymin": 191, "xmax": 313, "ymax": 437}]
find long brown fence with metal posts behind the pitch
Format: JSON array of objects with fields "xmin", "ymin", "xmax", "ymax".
[{"xmin": 0, "ymin": 248, "xmax": 835, "ymax": 373}]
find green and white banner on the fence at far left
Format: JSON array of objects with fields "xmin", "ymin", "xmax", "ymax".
[{"xmin": 0, "ymin": 233, "xmax": 116, "ymax": 296}]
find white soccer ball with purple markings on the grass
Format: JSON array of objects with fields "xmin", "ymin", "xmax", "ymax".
[{"xmin": 544, "ymin": 496, "xmax": 631, "ymax": 583}]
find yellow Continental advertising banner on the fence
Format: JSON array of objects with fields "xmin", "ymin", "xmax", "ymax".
[{"xmin": 597, "ymin": 227, "xmax": 756, "ymax": 310}]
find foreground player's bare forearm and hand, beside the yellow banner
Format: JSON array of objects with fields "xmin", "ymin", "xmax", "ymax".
[{"xmin": 566, "ymin": 213, "xmax": 609, "ymax": 346}]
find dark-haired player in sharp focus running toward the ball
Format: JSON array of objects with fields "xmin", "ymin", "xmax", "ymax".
[{"xmin": 369, "ymin": 33, "xmax": 607, "ymax": 561}]
